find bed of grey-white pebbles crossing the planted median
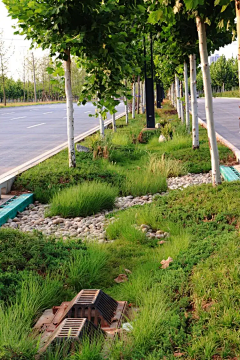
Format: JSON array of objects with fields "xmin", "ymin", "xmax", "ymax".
[{"xmin": 2, "ymin": 173, "xmax": 211, "ymax": 243}]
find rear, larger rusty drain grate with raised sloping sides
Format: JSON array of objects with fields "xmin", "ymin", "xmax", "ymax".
[{"xmin": 67, "ymin": 290, "xmax": 118, "ymax": 327}]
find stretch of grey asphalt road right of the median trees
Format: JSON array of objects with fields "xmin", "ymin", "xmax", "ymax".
[{"xmin": 198, "ymin": 98, "xmax": 240, "ymax": 150}]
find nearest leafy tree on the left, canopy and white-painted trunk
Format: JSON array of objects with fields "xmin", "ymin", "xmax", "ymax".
[{"xmin": 4, "ymin": 0, "xmax": 102, "ymax": 167}]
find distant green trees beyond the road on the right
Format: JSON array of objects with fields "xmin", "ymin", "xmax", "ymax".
[{"xmin": 197, "ymin": 55, "xmax": 238, "ymax": 92}]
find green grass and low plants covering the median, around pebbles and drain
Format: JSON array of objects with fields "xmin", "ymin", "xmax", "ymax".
[{"xmin": 0, "ymin": 102, "xmax": 240, "ymax": 360}]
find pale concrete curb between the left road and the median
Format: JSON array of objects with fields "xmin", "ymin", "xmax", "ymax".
[{"xmin": 0, "ymin": 112, "xmax": 126, "ymax": 198}]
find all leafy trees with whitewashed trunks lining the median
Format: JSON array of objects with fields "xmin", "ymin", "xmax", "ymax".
[{"xmin": 3, "ymin": 0, "xmax": 240, "ymax": 184}]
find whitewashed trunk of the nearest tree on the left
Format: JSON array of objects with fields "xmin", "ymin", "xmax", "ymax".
[{"xmin": 64, "ymin": 50, "xmax": 76, "ymax": 167}]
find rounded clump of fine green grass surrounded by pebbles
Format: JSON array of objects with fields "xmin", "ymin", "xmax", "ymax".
[{"xmin": 47, "ymin": 181, "xmax": 118, "ymax": 218}]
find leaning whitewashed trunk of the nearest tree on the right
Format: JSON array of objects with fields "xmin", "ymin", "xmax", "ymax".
[{"xmin": 196, "ymin": 16, "xmax": 221, "ymax": 186}]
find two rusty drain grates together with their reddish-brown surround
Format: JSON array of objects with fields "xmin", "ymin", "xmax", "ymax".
[{"xmin": 34, "ymin": 289, "xmax": 127, "ymax": 354}]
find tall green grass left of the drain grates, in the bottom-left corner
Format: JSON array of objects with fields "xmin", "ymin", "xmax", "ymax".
[{"xmin": 0, "ymin": 273, "xmax": 64, "ymax": 359}]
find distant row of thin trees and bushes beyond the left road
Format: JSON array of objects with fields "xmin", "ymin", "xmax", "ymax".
[{"xmin": 0, "ymin": 33, "xmax": 85, "ymax": 105}]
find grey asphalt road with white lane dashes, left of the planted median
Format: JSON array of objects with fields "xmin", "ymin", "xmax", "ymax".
[{"xmin": 0, "ymin": 103, "xmax": 124, "ymax": 175}]
